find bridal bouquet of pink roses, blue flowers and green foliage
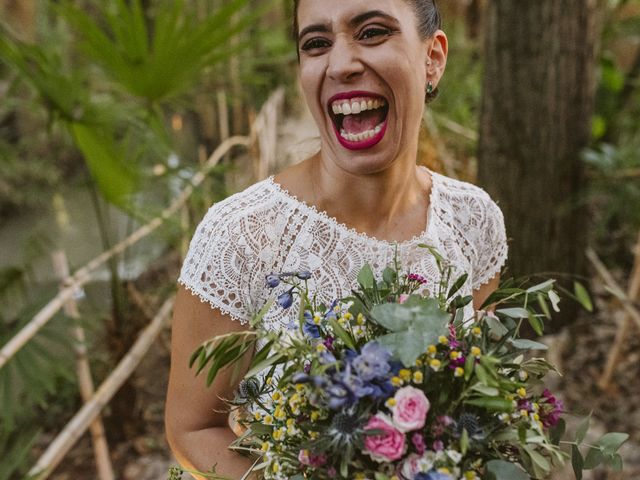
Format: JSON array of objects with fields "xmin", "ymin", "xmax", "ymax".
[{"xmin": 185, "ymin": 246, "xmax": 628, "ymax": 480}]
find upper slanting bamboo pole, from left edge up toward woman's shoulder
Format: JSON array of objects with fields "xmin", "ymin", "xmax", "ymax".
[{"xmin": 0, "ymin": 136, "xmax": 252, "ymax": 368}]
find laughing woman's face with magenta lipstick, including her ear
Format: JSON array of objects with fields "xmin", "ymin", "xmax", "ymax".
[{"xmin": 298, "ymin": 0, "xmax": 447, "ymax": 174}]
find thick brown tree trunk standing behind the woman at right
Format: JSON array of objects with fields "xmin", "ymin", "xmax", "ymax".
[{"xmin": 478, "ymin": 0, "xmax": 603, "ymax": 326}]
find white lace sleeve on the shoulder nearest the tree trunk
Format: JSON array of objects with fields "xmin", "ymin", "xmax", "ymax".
[{"xmin": 472, "ymin": 195, "xmax": 508, "ymax": 289}]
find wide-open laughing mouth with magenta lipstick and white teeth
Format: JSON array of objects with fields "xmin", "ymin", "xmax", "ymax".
[{"xmin": 329, "ymin": 92, "xmax": 389, "ymax": 150}]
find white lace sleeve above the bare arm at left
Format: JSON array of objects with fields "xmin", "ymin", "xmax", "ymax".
[{"xmin": 178, "ymin": 202, "xmax": 255, "ymax": 324}]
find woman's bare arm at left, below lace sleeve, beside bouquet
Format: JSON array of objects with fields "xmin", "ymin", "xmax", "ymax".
[{"xmin": 165, "ymin": 287, "xmax": 255, "ymax": 479}]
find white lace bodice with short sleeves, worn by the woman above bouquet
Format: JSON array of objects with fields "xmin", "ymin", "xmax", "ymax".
[{"xmin": 179, "ymin": 172, "xmax": 507, "ymax": 330}]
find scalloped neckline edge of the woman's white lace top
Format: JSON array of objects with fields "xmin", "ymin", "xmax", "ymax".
[{"xmin": 265, "ymin": 165, "xmax": 438, "ymax": 247}]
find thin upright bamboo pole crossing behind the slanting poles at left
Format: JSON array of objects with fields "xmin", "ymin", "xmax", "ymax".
[{"xmin": 51, "ymin": 250, "xmax": 115, "ymax": 480}]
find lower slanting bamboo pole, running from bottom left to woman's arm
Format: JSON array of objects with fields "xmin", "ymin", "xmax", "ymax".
[{"xmin": 28, "ymin": 295, "xmax": 175, "ymax": 480}]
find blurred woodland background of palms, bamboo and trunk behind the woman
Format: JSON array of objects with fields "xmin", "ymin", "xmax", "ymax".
[{"xmin": 0, "ymin": 0, "xmax": 640, "ymax": 480}]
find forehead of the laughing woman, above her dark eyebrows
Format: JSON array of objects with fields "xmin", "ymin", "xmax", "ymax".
[{"xmin": 298, "ymin": 0, "xmax": 414, "ymax": 29}]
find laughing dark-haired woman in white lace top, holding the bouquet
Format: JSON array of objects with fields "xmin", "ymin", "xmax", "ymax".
[{"xmin": 166, "ymin": 0, "xmax": 507, "ymax": 478}]
